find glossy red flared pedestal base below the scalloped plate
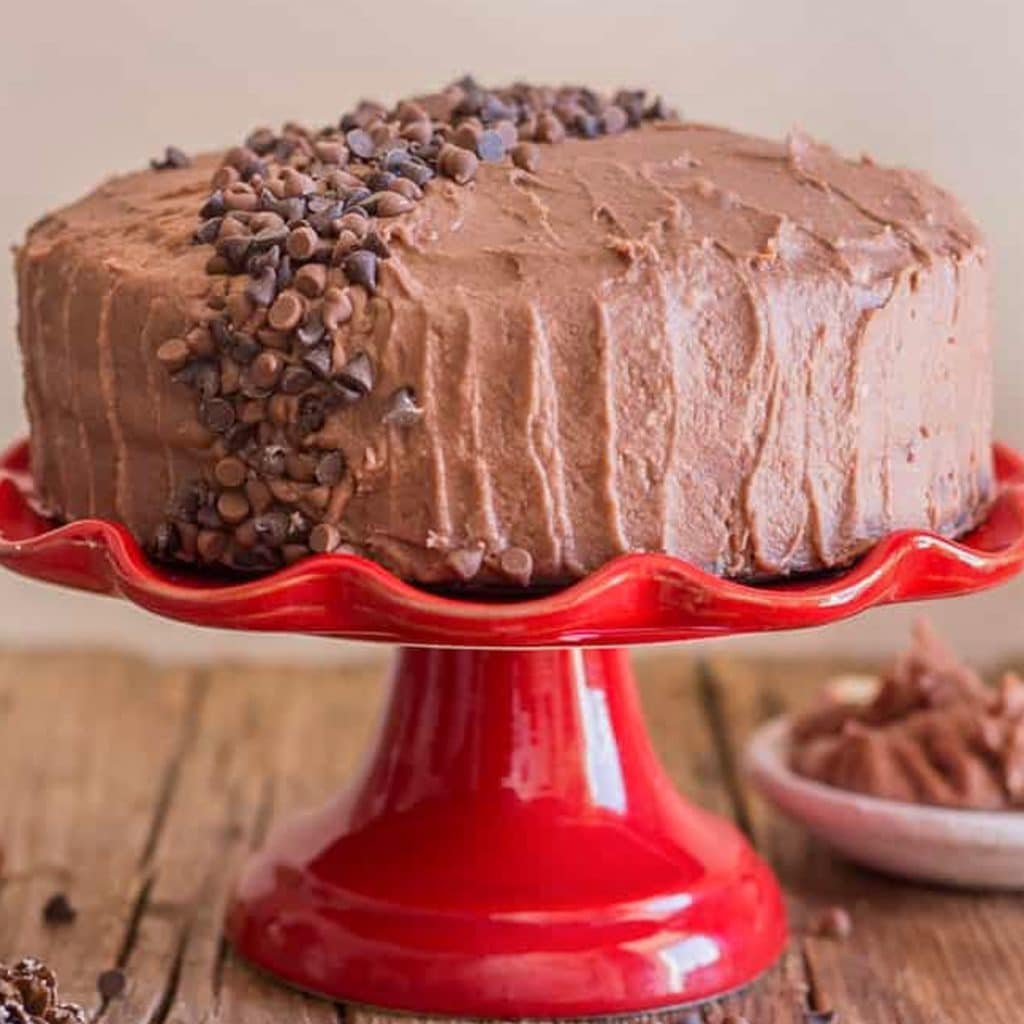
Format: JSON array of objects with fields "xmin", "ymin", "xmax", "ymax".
[{"xmin": 228, "ymin": 648, "xmax": 785, "ymax": 1018}]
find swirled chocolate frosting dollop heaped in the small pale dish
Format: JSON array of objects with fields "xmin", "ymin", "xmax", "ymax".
[{"xmin": 790, "ymin": 622, "xmax": 1024, "ymax": 810}]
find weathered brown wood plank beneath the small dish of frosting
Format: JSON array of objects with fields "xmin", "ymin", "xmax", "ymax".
[{"xmin": 711, "ymin": 658, "xmax": 1024, "ymax": 1024}]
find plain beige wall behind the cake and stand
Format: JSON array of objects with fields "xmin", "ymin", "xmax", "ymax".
[{"xmin": 0, "ymin": 0, "xmax": 1024, "ymax": 656}]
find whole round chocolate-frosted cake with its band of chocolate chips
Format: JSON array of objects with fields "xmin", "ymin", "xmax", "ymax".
[{"xmin": 17, "ymin": 80, "xmax": 993, "ymax": 586}]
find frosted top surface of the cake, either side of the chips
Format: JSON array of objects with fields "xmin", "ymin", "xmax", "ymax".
[{"xmin": 24, "ymin": 100, "xmax": 982, "ymax": 299}]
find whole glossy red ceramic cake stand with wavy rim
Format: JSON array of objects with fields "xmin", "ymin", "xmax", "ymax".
[{"xmin": 0, "ymin": 444, "xmax": 1024, "ymax": 1018}]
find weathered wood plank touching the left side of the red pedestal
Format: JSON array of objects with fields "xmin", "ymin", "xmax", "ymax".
[{"xmin": 108, "ymin": 666, "xmax": 380, "ymax": 1024}]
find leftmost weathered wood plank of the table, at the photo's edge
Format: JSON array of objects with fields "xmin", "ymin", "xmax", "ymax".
[{"xmin": 0, "ymin": 652, "xmax": 195, "ymax": 1005}]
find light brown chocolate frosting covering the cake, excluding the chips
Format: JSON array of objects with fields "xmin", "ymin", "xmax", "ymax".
[{"xmin": 16, "ymin": 112, "xmax": 993, "ymax": 583}]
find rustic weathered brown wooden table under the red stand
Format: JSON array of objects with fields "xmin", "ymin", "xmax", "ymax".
[{"xmin": 0, "ymin": 648, "xmax": 1024, "ymax": 1024}]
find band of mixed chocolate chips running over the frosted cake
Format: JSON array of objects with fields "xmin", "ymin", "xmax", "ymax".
[{"xmin": 151, "ymin": 78, "xmax": 668, "ymax": 586}]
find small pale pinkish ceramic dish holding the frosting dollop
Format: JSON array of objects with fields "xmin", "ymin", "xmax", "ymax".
[{"xmin": 745, "ymin": 704, "xmax": 1024, "ymax": 889}]
